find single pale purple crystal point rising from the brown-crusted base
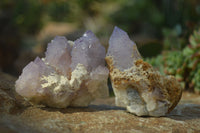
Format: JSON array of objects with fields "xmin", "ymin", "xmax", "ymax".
[{"xmin": 107, "ymin": 26, "xmax": 141, "ymax": 70}]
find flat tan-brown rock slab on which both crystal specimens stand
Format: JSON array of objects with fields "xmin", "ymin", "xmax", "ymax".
[{"xmin": 0, "ymin": 73, "xmax": 200, "ymax": 133}]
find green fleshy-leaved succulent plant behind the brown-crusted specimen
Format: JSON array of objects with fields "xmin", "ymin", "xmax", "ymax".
[{"xmin": 146, "ymin": 29, "xmax": 200, "ymax": 93}]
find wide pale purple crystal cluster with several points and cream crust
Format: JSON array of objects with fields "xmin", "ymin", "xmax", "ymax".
[{"xmin": 15, "ymin": 31, "xmax": 109, "ymax": 108}]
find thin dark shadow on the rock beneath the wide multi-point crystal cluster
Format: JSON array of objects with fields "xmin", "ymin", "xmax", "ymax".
[{"xmin": 41, "ymin": 104, "xmax": 126, "ymax": 113}]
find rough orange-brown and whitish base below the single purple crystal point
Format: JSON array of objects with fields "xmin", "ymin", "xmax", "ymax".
[{"xmin": 106, "ymin": 57, "xmax": 182, "ymax": 116}]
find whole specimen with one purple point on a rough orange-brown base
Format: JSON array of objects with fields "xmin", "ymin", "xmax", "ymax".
[{"xmin": 106, "ymin": 27, "xmax": 182, "ymax": 116}]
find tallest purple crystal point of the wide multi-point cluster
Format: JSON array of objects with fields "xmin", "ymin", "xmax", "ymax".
[{"xmin": 71, "ymin": 31, "xmax": 106, "ymax": 71}]
